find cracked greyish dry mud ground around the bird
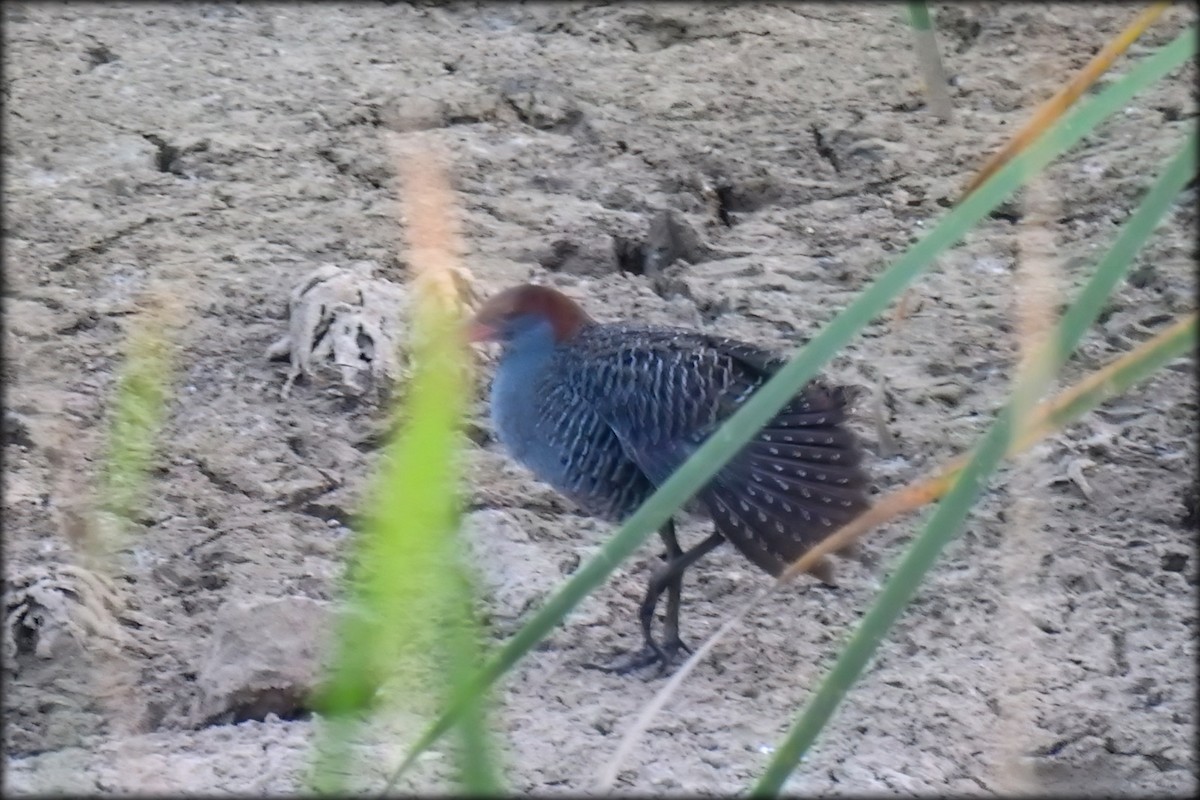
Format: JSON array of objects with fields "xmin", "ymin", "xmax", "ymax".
[{"xmin": 4, "ymin": 2, "xmax": 1198, "ymax": 796}]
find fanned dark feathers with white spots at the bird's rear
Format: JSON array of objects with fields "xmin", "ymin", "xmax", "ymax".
[{"xmin": 700, "ymin": 385, "xmax": 868, "ymax": 582}]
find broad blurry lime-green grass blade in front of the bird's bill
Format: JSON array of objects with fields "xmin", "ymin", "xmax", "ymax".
[{"xmin": 312, "ymin": 283, "xmax": 502, "ymax": 796}]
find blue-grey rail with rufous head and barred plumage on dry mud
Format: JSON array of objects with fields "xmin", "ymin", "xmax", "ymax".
[{"xmin": 467, "ymin": 283, "xmax": 869, "ymax": 673}]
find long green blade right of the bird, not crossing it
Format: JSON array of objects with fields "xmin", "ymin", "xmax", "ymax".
[{"xmin": 751, "ymin": 133, "xmax": 1198, "ymax": 796}]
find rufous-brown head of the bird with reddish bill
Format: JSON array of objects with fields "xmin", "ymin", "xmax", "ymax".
[{"xmin": 468, "ymin": 283, "xmax": 593, "ymax": 345}]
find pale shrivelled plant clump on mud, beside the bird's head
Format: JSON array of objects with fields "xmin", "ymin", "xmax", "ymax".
[{"xmin": 266, "ymin": 261, "xmax": 474, "ymax": 397}]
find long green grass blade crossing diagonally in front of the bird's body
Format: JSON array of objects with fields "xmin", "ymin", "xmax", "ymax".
[{"xmin": 388, "ymin": 30, "xmax": 1195, "ymax": 786}]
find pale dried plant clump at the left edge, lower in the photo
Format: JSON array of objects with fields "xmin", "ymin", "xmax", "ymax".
[{"xmin": 4, "ymin": 564, "xmax": 150, "ymax": 670}]
